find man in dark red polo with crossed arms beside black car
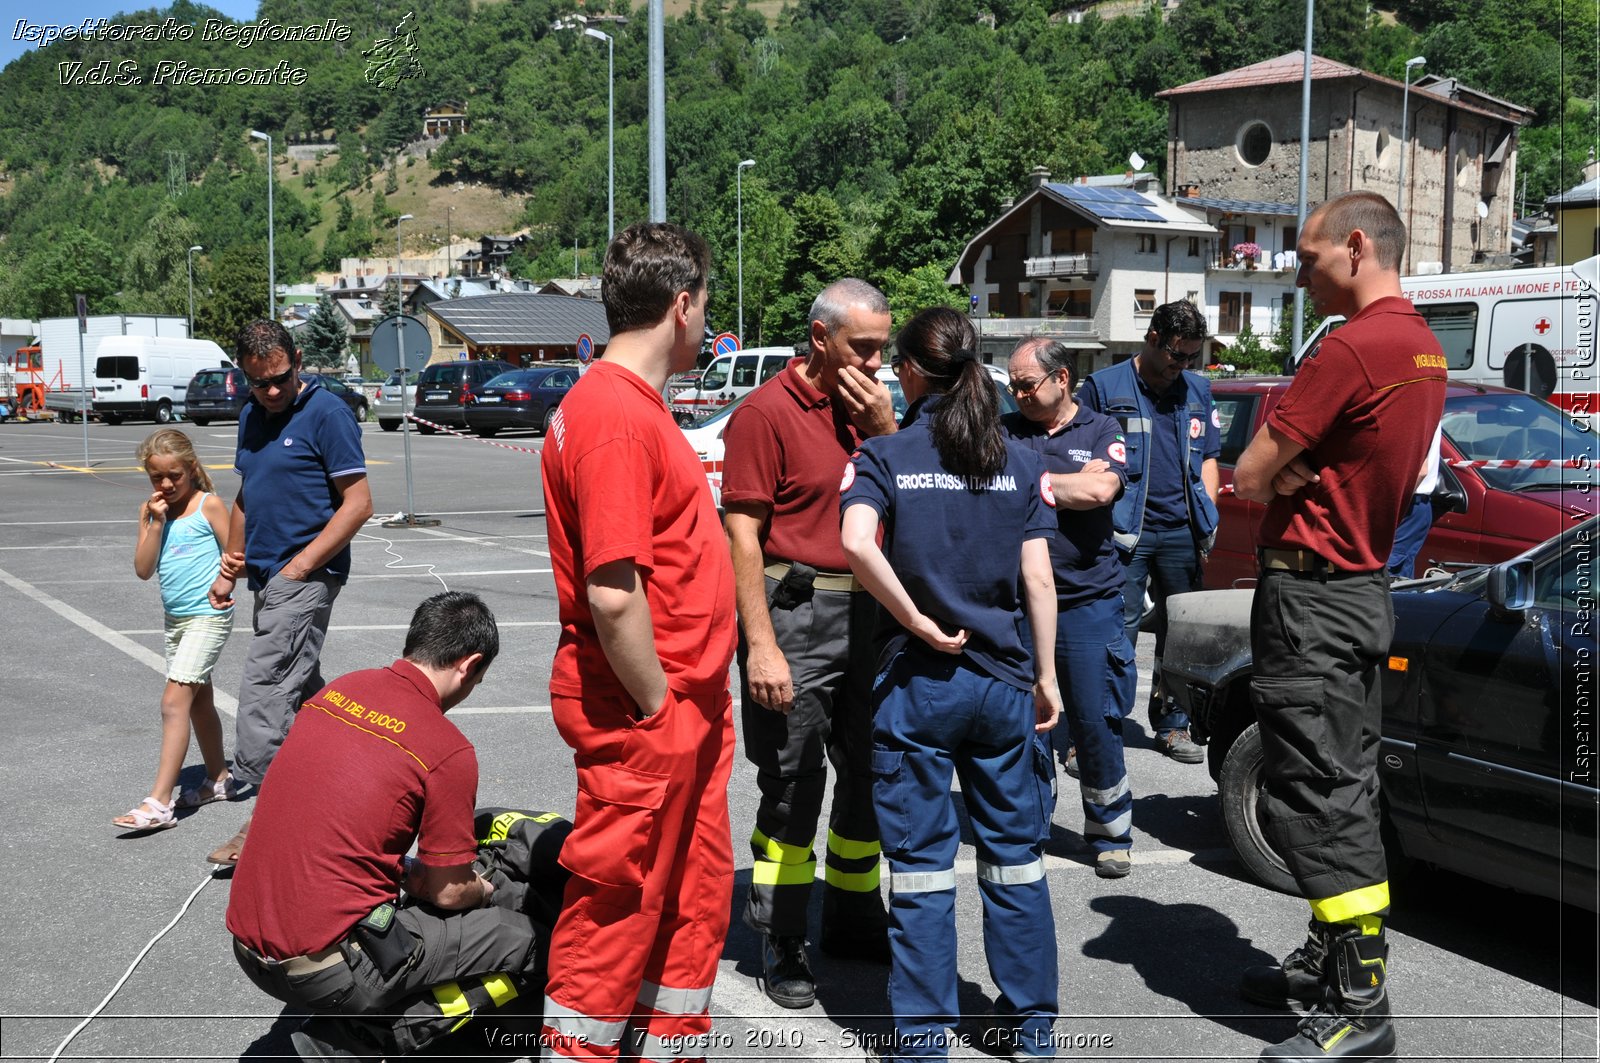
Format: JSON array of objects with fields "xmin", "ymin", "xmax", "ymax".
[{"xmin": 1234, "ymin": 192, "xmax": 1445, "ymax": 1060}]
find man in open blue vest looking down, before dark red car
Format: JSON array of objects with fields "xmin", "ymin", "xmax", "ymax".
[{"xmin": 1078, "ymin": 299, "xmax": 1222, "ymax": 764}]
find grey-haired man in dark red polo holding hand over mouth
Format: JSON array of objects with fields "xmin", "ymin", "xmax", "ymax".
[{"xmin": 722, "ymin": 279, "xmax": 894, "ymax": 1007}]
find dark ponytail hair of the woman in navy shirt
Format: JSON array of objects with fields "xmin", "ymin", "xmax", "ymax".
[{"xmin": 896, "ymin": 306, "xmax": 1006, "ymax": 480}]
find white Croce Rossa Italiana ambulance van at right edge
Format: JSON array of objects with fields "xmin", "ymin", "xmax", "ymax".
[{"xmin": 1302, "ymin": 256, "xmax": 1600, "ymax": 424}]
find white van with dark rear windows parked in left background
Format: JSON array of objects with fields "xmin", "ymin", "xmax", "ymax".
[{"xmin": 93, "ymin": 336, "xmax": 230, "ymax": 424}]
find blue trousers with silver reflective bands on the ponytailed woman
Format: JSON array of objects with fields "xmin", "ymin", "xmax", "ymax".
[{"xmin": 872, "ymin": 652, "xmax": 1058, "ymax": 1060}]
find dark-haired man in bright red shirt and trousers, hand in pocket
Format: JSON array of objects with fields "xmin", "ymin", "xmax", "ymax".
[{"xmin": 541, "ymin": 223, "xmax": 736, "ymax": 1063}]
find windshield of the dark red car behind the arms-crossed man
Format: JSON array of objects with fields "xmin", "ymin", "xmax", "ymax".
[{"xmin": 1442, "ymin": 392, "xmax": 1597, "ymax": 491}]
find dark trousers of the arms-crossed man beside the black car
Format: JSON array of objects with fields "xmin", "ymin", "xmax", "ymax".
[{"xmin": 1250, "ymin": 570, "xmax": 1394, "ymax": 917}]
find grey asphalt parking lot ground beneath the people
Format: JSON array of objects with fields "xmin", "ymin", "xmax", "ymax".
[{"xmin": 0, "ymin": 423, "xmax": 1600, "ymax": 1060}]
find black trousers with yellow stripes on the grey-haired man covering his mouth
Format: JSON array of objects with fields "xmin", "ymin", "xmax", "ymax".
[{"xmin": 739, "ymin": 576, "xmax": 883, "ymax": 937}]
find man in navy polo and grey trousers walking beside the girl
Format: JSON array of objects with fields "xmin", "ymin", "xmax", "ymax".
[{"xmin": 206, "ymin": 320, "xmax": 373, "ymax": 864}]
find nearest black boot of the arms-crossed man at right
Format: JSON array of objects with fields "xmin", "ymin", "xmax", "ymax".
[{"xmin": 1261, "ymin": 925, "xmax": 1395, "ymax": 1063}]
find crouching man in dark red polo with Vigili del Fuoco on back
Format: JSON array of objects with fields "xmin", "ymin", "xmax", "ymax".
[{"xmin": 227, "ymin": 592, "xmax": 542, "ymax": 1060}]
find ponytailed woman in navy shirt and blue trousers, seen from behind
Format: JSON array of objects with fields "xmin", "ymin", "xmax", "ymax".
[{"xmin": 840, "ymin": 307, "xmax": 1061, "ymax": 1060}]
